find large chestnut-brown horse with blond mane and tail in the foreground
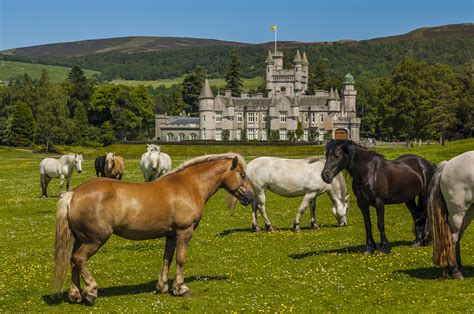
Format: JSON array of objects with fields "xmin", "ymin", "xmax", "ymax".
[{"xmin": 53, "ymin": 153, "xmax": 253, "ymax": 305}]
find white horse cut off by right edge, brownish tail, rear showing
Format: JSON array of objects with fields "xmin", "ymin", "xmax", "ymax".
[{"xmin": 428, "ymin": 151, "xmax": 474, "ymax": 279}]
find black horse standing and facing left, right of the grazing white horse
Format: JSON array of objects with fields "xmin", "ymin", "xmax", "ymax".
[{"xmin": 321, "ymin": 140, "xmax": 435, "ymax": 255}]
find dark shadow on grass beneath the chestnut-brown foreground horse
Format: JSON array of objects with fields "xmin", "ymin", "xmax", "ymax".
[{"xmin": 43, "ymin": 276, "xmax": 229, "ymax": 305}]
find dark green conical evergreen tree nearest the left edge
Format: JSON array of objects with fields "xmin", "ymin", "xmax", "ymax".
[{"xmin": 9, "ymin": 100, "xmax": 35, "ymax": 146}]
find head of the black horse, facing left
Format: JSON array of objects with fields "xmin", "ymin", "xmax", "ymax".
[{"xmin": 321, "ymin": 140, "xmax": 354, "ymax": 183}]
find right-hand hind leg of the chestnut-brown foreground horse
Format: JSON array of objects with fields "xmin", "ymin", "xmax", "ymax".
[{"xmin": 71, "ymin": 241, "xmax": 105, "ymax": 305}]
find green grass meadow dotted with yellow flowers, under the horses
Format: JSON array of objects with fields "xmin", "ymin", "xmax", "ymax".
[{"xmin": 0, "ymin": 140, "xmax": 474, "ymax": 312}]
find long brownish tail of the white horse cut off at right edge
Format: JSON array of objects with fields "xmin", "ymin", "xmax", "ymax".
[{"xmin": 427, "ymin": 161, "xmax": 456, "ymax": 267}]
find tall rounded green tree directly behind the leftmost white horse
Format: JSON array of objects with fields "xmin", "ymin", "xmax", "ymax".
[{"xmin": 37, "ymin": 84, "xmax": 72, "ymax": 151}]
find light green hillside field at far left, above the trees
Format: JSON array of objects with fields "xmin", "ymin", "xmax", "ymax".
[{"xmin": 0, "ymin": 61, "xmax": 100, "ymax": 82}]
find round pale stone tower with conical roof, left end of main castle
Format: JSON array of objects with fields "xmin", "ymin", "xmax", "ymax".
[{"xmin": 199, "ymin": 79, "xmax": 216, "ymax": 140}]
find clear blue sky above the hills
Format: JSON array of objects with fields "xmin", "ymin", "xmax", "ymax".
[{"xmin": 0, "ymin": 0, "xmax": 474, "ymax": 50}]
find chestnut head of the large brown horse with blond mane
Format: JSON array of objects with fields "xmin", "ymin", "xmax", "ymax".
[{"xmin": 223, "ymin": 156, "xmax": 254, "ymax": 208}]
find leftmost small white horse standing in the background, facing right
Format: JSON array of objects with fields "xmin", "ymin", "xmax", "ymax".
[{"xmin": 40, "ymin": 154, "xmax": 83, "ymax": 197}]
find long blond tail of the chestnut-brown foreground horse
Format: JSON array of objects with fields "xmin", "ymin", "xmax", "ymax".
[{"xmin": 53, "ymin": 192, "xmax": 74, "ymax": 294}]
